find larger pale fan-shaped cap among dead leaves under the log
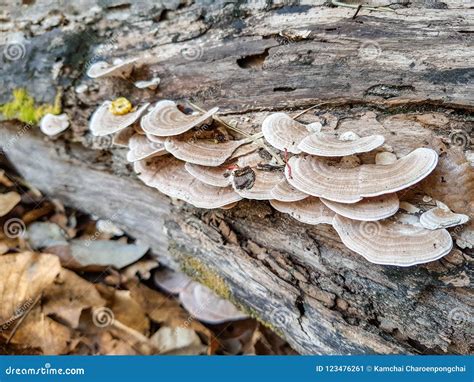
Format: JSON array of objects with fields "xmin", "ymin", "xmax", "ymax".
[{"xmin": 179, "ymin": 282, "xmax": 247, "ymax": 324}]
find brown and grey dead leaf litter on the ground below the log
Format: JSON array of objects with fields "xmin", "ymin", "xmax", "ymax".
[{"xmin": 0, "ymin": 169, "xmax": 295, "ymax": 355}]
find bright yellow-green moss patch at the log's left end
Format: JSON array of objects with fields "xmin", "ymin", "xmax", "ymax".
[{"xmin": 0, "ymin": 88, "xmax": 62, "ymax": 124}]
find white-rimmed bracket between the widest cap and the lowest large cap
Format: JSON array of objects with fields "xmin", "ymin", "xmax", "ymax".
[{"xmin": 321, "ymin": 193, "xmax": 399, "ymax": 221}]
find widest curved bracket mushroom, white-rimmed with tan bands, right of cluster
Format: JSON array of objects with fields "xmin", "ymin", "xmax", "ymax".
[{"xmin": 285, "ymin": 148, "xmax": 438, "ymax": 203}]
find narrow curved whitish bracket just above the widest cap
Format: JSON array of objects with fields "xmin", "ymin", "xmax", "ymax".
[{"xmin": 298, "ymin": 133, "xmax": 385, "ymax": 157}]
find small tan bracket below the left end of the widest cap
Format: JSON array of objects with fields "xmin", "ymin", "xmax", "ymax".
[{"xmin": 270, "ymin": 196, "xmax": 335, "ymax": 225}]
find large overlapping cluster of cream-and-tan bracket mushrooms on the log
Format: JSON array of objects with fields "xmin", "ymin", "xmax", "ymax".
[{"xmin": 90, "ymin": 62, "xmax": 468, "ymax": 266}]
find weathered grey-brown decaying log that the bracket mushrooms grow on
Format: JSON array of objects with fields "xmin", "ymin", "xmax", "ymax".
[{"xmin": 0, "ymin": 1, "xmax": 474, "ymax": 354}]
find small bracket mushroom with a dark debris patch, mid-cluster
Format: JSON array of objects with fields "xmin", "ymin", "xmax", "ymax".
[{"xmin": 230, "ymin": 167, "xmax": 284, "ymax": 200}]
